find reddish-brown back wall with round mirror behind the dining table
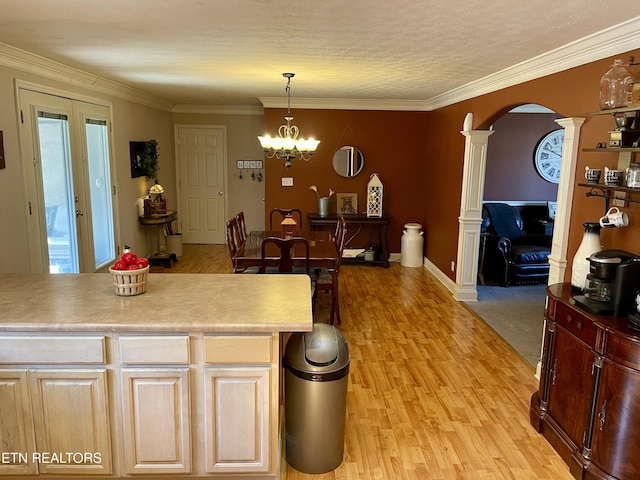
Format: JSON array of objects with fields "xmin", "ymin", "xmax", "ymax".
[{"xmin": 264, "ymin": 109, "xmax": 431, "ymax": 252}]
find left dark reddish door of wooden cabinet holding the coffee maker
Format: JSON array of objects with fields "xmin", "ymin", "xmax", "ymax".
[{"xmin": 547, "ymin": 326, "xmax": 595, "ymax": 447}]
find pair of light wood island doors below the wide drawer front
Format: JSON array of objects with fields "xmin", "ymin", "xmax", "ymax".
[{"xmin": 0, "ymin": 369, "xmax": 112, "ymax": 475}]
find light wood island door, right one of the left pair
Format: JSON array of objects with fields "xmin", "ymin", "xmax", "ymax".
[{"xmin": 29, "ymin": 369, "xmax": 111, "ymax": 475}]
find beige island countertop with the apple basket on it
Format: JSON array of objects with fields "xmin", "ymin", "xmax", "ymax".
[{"xmin": 0, "ymin": 273, "xmax": 312, "ymax": 332}]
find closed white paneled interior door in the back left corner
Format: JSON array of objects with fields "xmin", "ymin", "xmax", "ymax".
[{"xmin": 176, "ymin": 126, "xmax": 226, "ymax": 244}]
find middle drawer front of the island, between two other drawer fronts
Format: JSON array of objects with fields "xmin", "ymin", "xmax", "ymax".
[{"xmin": 120, "ymin": 335, "xmax": 190, "ymax": 365}]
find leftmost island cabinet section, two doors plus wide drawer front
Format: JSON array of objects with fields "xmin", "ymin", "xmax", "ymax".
[{"xmin": 0, "ymin": 335, "xmax": 113, "ymax": 475}]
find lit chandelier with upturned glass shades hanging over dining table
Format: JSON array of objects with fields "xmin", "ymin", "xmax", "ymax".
[{"xmin": 258, "ymin": 73, "xmax": 320, "ymax": 168}]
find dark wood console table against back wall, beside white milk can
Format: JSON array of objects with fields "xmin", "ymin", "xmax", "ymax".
[{"xmin": 307, "ymin": 213, "xmax": 391, "ymax": 268}]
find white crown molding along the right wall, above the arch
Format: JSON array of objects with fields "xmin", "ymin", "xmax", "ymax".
[{"xmin": 425, "ymin": 17, "xmax": 640, "ymax": 110}]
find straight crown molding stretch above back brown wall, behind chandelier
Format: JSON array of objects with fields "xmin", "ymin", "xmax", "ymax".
[{"xmin": 258, "ymin": 97, "xmax": 430, "ymax": 112}]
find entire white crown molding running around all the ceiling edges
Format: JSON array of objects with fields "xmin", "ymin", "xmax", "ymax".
[{"xmin": 0, "ymin": 17, "xmax": 640, "ymax": 115}]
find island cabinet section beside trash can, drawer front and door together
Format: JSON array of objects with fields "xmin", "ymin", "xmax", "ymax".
[{"xmin": 203, "ymin": 335, "xmax": 279, "ymax": 474}]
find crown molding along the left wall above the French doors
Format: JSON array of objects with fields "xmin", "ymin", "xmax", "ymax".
[{"xmin": 0, "ymin": 43, "xmax": 173, "ymax": 111}]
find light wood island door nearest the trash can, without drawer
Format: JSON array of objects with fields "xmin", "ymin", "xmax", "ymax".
[{"xmin": 204, "ymin": 365, "xmax": 271, "ymax": 473}]
